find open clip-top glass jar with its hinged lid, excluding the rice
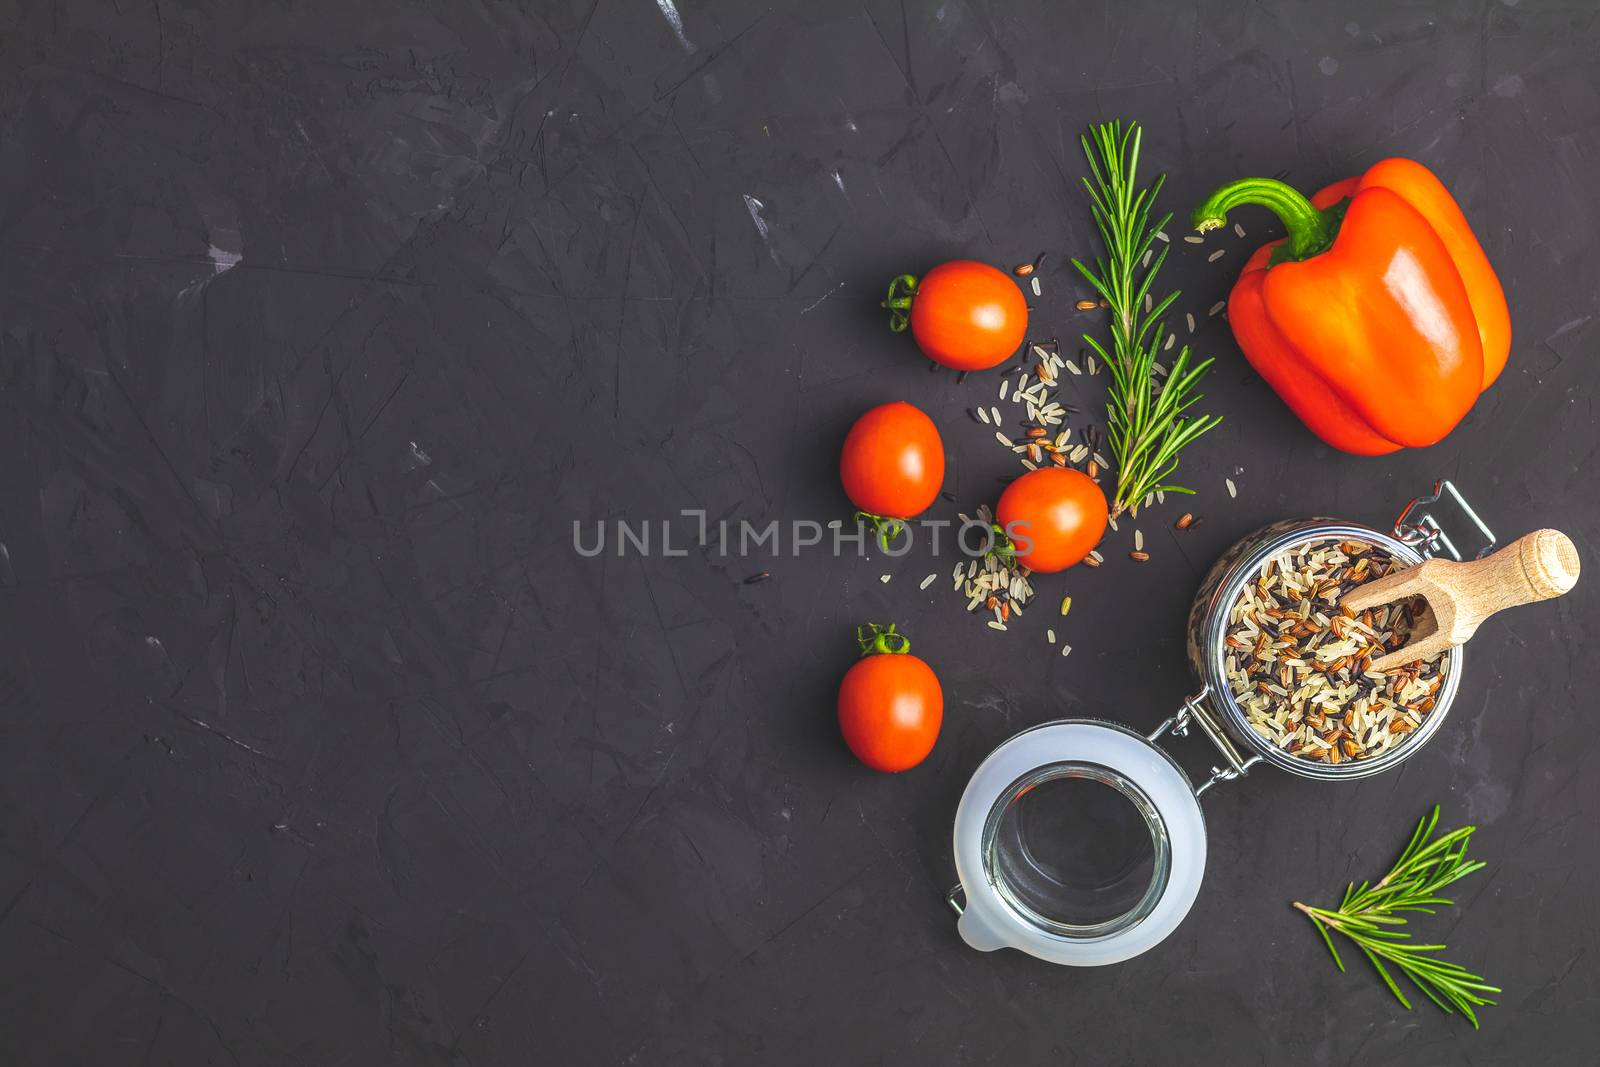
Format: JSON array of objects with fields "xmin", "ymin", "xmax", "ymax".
[{"xmin": 949, "ymin": 482, "xmax": 1494, "ymax": 966}]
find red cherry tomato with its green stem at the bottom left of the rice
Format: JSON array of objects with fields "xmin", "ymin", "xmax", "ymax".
[{"xmin": 838, "ymin": 400, "xmax": 944, "ymax": 518}]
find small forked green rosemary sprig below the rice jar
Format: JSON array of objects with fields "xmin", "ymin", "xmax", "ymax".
[{"xmin": 1294, "ymin": 805, "xmax": 1501, "ymax": 1029}]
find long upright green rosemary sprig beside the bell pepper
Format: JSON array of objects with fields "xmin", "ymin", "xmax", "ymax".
[{"xmin": 1072, "ymin": 122, "xmax": 1221, "ymax": 517}]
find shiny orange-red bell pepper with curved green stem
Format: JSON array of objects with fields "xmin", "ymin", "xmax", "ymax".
[{"xmin": 1194, "ymin": 158, "xmax": 1510, "ymax": 456}]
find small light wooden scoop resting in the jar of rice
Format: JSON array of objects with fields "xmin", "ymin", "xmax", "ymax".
[{"xmin": 1339, "ymin": 530, "xmax": 1578, "ymax": 670}]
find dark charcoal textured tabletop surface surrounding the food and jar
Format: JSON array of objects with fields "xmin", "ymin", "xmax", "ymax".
[{"xmin": 0, "ymin": 0, "xmax": 1600, "ymax": 1067}]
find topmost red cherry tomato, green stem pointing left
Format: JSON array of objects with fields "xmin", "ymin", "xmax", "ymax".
[{"xmin": 885, "ymin": 259, "xmax": 1027, "ymax": 371}]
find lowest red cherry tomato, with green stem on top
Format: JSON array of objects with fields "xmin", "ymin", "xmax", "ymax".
[{"xmin": 838, "ymin": 625, "xmax": 944, "ymax": 771}]
